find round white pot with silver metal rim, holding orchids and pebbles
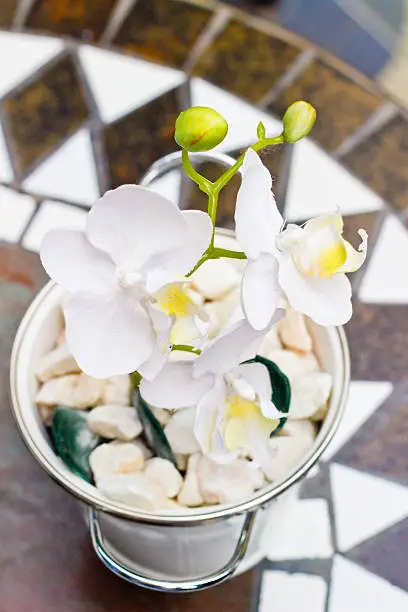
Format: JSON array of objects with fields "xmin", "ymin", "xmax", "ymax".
[{"xmin": 7, "ymin": 154, "xmax": 349, "ymax": 592}]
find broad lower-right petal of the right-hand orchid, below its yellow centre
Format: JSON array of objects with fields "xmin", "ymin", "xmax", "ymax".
[{"xmin": 279, "ymin": 257, "xmax": 352, "ymax": 325}]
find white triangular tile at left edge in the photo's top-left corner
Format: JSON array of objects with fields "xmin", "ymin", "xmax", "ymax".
[{"xmin": 0, "ymin": 32, "xmax": 64, "ymax": 97}]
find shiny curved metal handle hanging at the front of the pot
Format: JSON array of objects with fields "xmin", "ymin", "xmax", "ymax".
[{"xmin": 89, "ymin": 507, "xmax": 256, "ymax": 593}]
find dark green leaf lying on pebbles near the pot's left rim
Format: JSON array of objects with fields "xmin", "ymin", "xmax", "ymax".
[{"xmin": 51, "ymin": 406, "xmax": 101, "ymax": 482}]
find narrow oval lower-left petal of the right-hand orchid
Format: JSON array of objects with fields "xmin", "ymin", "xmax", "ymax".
[{"xmin": 242, "ymin": 253, "xmax": 281, "ymax": 330}]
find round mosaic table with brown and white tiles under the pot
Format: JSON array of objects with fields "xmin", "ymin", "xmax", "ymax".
[{"xmin": 0, "ymin": 0, "xmax": 408, "ymax": 612}]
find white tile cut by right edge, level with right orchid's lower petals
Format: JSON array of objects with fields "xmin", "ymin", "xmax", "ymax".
[{"xmin": 359, "ymin": 215, "xmax": 408, "ymax": 304}]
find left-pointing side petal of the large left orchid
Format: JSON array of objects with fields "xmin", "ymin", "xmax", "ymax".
[{"xmin": 40, "ymin": 229, "xmax": 115, "ymax": 291}]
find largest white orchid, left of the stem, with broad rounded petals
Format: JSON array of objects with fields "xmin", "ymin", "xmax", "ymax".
[{"xmin": 41, "ymin": 185, "xmax": 212, "ymax": 378}]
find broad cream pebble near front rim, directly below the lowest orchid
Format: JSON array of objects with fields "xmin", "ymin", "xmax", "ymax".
[{"xmin": 197, "ymin": 456, "xmax": 263, "ymax": 504}]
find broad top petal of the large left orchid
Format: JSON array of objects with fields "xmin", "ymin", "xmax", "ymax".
[{"xmin": 86, "ymin": 185, "xmax": 187, "ymax": 269}]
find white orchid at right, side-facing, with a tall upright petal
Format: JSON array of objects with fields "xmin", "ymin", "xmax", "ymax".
[{"xmin": 235, "ymin": 149, "xmax": 367, "ymax": 330}]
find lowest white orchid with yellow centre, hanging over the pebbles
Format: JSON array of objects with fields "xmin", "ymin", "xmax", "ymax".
[{"xmin": 140, "ymin": 310, "xmax": 282, "ymax": 463}]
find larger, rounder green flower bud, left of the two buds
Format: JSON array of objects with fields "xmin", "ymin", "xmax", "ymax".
[{"xmin": 174, "ymin": 106, "xmax": 228, "ymax": 153}]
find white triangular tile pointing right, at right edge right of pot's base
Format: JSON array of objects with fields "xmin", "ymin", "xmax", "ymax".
[{"xmin": 330, "ymin": 463, "xmax": 408, "ymax": 552}]
